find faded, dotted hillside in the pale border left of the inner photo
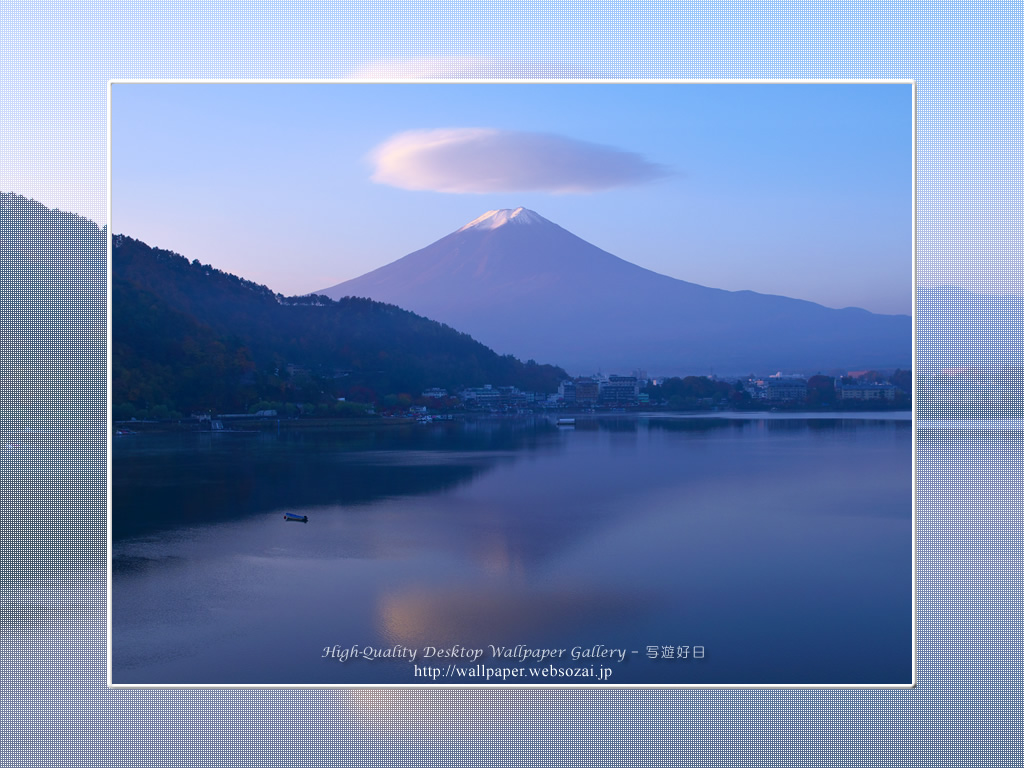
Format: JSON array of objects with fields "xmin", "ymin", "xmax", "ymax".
[{"xmin": 0, "ymin": 193, "xmax": 106, "ymax": 444}]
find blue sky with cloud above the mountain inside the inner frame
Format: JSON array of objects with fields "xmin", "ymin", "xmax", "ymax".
[{"xmin": 111, "ymin": 83, "xmax": 912, "ymax": 313}]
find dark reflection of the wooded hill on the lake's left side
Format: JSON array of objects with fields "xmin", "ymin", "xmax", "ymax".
[{"xmin": 113, "ymin": 423, "xmax": 541, "ymax": 539}]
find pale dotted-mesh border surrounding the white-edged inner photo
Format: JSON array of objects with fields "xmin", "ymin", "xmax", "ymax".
[{"xmin": 0, "ymin": 1, "xmax": 1011, "ymax": 767}]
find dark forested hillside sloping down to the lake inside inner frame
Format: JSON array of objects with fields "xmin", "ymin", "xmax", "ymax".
[{"xmin": 112, "ymin": 236, "xmax": 566, "ymax": 419}]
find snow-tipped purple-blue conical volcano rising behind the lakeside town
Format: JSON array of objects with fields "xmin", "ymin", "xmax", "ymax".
[{"xmin": 316, "ymin": 208, "xmax": 911, "ymax": 376}]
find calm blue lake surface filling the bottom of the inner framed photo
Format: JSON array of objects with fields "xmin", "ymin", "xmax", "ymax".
[{"xmin": 112, "ymin": 415, "xmax": 912, "ymax": 684}]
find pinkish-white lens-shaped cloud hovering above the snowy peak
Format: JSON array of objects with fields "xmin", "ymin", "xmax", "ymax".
[{"xmin": 371, "ymin": 128, "xmax": 667, "ymax": 194}]
